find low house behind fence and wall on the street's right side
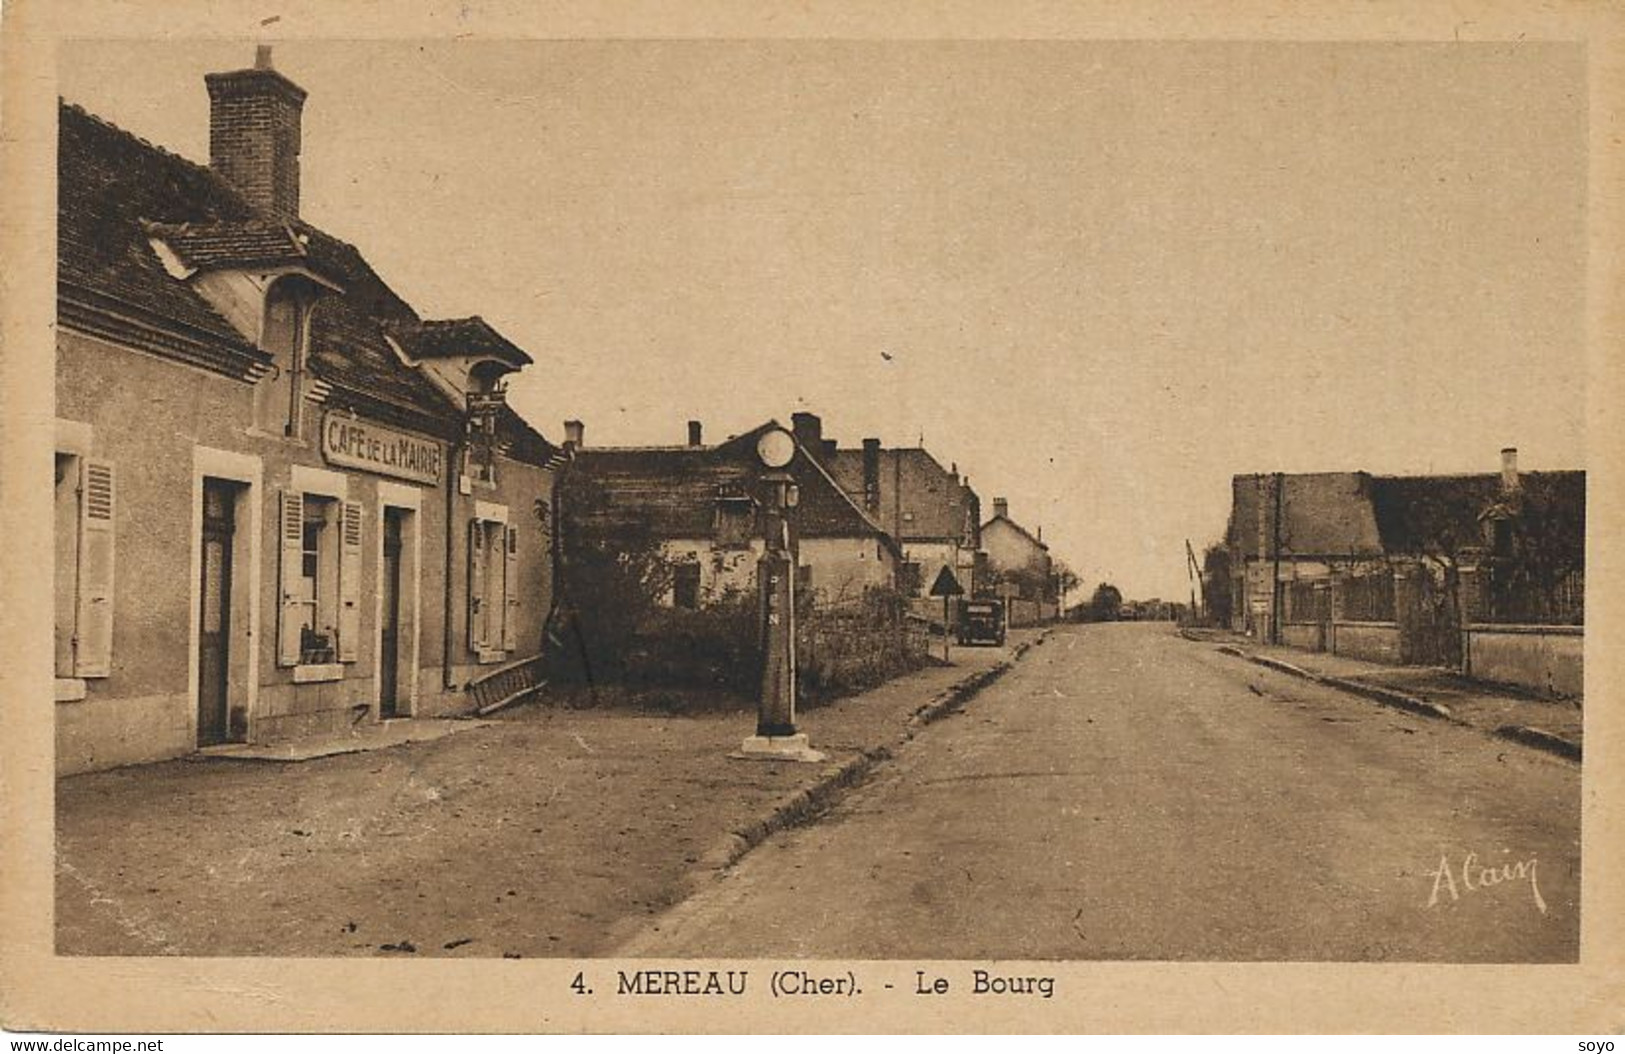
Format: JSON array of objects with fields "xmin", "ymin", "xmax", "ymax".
[{"xmin": 1229, "ymin": 450, "xmax": 1586, "ymax": 693}]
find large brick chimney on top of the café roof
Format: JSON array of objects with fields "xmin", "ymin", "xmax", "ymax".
[{"xmin": 203, "ymin": 44, "xmax": 306, "ymax": 221}]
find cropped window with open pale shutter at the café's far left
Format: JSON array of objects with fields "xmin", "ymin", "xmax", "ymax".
[{"xmin": 54, "ymin": 453, "xmax": 115, "ymax": 677}]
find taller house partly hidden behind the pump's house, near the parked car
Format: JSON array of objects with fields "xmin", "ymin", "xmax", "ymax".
[{"xmin": 791, "ymin": 413, "xmax": 982, "ymax": 614}]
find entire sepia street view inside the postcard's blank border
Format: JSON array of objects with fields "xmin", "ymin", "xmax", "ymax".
[{"xmin": 52, "ymin": 41, "xmax": 1586, "ymax": 963}]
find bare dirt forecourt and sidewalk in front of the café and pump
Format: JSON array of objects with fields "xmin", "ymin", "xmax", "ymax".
[{"xmin": 55, "ymin": 633, "xmax": 1037, "ymax": 958}]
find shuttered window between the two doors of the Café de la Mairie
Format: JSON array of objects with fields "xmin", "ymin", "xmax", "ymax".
[{"xmin": 276, "ymin": 490, "xmax": 362, "ymax": 666}]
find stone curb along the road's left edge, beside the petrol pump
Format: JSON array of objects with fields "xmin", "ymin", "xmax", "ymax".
[{"xmin": 684, "ymin": 630, "xmax": 1050, "ymax": 876}]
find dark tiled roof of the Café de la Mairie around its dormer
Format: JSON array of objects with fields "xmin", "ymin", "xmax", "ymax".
[{"xmin": 57, "ymin": 104, "xmax": 481, "ymax": 434}]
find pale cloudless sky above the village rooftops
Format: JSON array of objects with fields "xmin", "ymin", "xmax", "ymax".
[{"xmin": 60, "ymin": 41, "xmax": 1586, "ymax": 598}]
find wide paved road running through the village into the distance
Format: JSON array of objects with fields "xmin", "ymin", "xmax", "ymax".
[{"xmin": 621, "ymin": 624, "xmax": 1580, "ymax": 961}]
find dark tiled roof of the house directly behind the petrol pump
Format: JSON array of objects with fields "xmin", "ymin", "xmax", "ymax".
[{"xmin": 566, "ymin": 422, "xmax": 895, "ymax": 552}]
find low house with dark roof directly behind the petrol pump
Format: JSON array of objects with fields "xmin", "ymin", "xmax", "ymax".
[{"xmin": 562, "ymin": 421, "xmax": 902, "ymax": 607}]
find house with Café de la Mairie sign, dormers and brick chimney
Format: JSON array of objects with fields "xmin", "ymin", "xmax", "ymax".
[{"xmin": 54, "ymin": 49, "xmax": 557, "ymax": 771}]
